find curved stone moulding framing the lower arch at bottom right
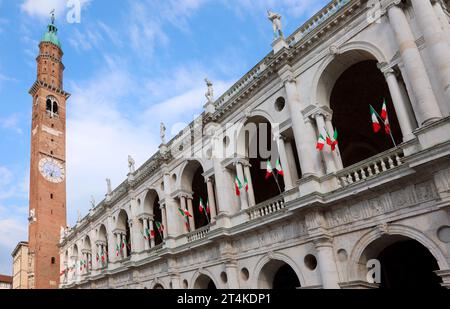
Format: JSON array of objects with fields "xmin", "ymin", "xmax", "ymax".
[{"xmin": 347, "ymin": 224, "xmax": 449, "ymax": 281}]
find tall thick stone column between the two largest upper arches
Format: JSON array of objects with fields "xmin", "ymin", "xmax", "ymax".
[{"xmin": 284, "ymin": 75, "xmax": 323, "ymax": 177}]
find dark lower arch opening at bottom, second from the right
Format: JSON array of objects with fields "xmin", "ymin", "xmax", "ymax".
[{"xmin": 258, "ymin": 260, "xmax": 301, "ymax": 290}]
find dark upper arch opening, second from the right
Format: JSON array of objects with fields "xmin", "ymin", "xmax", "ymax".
[{"xmin": 239, "ymin": 116, "xmax": 285, "ymax": 204}]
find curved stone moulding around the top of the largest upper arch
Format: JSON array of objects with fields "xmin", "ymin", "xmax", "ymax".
[{"xmin": 309, "ymin": 41, "xmax": 389, "ymax": 105}]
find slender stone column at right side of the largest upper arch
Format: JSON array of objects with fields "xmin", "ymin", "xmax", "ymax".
[{"xmin": 382, "ymin": 68, "xmax": 414, "ymax": 141}]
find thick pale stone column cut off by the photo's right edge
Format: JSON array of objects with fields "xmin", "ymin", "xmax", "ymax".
[{"xmin": 411, "ymin": 0, "xmax": 450, "ymax": 102}]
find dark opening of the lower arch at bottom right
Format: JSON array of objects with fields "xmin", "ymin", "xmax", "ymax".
[{"xmin": 361, "ymin": 235, "xmax": 442, "ymax": 289}]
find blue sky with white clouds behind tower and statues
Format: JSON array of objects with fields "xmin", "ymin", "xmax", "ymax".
[{"xmin": 0, "ymin": 0, "xmax": 328, "ymax": 274}]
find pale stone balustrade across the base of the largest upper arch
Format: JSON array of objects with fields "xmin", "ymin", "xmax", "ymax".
[{"xmin": 336, "ymin": 148, "xmax": 405, "ymax": 187}]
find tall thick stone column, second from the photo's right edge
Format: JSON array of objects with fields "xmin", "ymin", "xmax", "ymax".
[{"xmin": 387, "ymin": 0, "xmax": 442, "ymax": 125}]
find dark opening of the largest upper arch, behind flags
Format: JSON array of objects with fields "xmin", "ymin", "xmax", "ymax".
[{"xmin": 330, "ymin": 60, "xmax": 402, "ymax": 166}]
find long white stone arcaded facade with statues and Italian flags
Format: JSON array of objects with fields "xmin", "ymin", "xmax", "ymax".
[{"xmin": 60, "ymin": 0, "xmax": 450, "ymax": 289}]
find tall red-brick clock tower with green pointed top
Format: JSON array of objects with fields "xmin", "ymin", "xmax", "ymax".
[{"xmin": 28, "ymin": 14, "xmax": 70, "ymax": 289}]
